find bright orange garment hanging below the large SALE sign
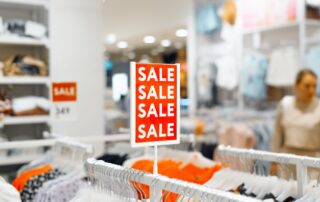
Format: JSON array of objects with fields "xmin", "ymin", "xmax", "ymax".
[{"xmin": 132, "ymin": 160, "xmax": 222, "ymax": 202}]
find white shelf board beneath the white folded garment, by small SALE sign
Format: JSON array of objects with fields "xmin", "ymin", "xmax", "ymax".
[{"xmin": 3, "ymin": 115, "xmax": 50, "ymax": 125}]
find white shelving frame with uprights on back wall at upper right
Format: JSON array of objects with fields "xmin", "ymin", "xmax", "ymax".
[{"xmin": 188, "ymin": 0, "xmax": 320, "ymax": 115}]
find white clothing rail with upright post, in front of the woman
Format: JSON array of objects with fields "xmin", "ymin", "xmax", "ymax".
[{"xmin": 218, "ymin": 145, "xmax": 320, "ymax": 197}]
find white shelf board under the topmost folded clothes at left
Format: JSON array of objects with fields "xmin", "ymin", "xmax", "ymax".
[{"xmin": 0, "ymin": 35, "xmax": 49, "ymax": 47}]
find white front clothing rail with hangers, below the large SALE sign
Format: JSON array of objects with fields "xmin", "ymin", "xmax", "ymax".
[{"xmin": 85, "ymin": 159, "xmax": 259, "ymax": 202}]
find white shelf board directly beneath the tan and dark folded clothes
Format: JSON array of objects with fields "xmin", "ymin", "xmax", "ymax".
[{"xmin": 0, "ymin": 76, "xmax": 50, "ymax": 85}]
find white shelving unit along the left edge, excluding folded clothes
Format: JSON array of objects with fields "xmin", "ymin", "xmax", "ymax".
[{"xmin": 0, "ymin": 0, "xmax": 53, "ymax": 166}]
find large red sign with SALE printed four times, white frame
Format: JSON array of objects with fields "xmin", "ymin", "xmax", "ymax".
[{"xmin": 130, "ymin": 62, "xmax": 180, "ymax": 147}]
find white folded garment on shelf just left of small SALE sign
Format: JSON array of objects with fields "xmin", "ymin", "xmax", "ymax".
[{"xmin": 12, "ymin": 96, "xmax": 50, "ymax": 113}]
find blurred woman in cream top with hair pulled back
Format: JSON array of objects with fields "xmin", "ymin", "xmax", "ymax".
[{"xmin": 272, "ymin": 69, "xmax": 320, "ymax": 157}]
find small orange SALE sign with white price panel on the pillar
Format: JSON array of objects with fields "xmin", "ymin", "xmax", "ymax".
[{"xmin": 51, "ymin": 82, "xmax": 77, "ymax": 121}]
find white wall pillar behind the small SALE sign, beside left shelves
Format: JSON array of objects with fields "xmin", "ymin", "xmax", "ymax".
[{"xmin": 50, "ymin": 0, "xmax": 105, "ymax": 139}]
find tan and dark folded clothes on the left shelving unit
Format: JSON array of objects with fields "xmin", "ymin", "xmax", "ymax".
[{"xmin": 2, "ymin": 55, "xmax": 48, "ymax": 76}]
